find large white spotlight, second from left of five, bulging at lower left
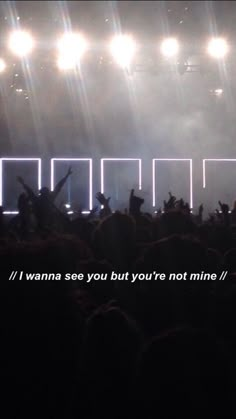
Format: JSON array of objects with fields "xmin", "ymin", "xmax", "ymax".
[{"xmin": 57, "ymin": 33, "xmax": 88, "ymax": 70}]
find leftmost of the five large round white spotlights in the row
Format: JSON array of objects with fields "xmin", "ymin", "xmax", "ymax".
[{"xmin": 9, "ymin": 31, "xmax": 34, "ymax": 57}]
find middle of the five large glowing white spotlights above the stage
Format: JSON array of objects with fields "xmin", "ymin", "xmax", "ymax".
[{"xmin": 110, "ymin": 35, "xmax": 136, "ymax": 68}]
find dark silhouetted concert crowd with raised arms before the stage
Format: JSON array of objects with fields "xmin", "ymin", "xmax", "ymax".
[{"xmin": 0, "ymin": 169, "xmax": 236, "ymax": 419}]
